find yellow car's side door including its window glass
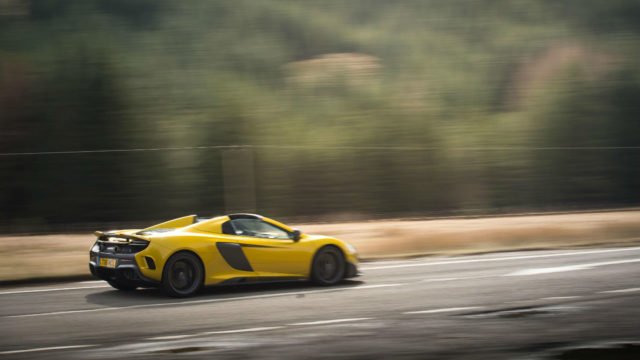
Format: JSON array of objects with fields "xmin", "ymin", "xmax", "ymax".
[{"xmin": 230, "ymin": 219, "xmax": 310, "ymax": 277}]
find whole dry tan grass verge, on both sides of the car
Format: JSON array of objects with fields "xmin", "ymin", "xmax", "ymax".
[{"xmin": 0, "ymin": 211, "xmax": 640, "ymax": 281}]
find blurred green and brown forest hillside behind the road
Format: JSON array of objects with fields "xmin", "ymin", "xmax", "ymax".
[{"xmin": 0, "ymin": 0, "xmax": 640, "ymax": 233}]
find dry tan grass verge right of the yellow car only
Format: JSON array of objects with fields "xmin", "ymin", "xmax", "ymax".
[{"xmin": 301, "ymin": 211, "xmax": 640, "ymax": 257}]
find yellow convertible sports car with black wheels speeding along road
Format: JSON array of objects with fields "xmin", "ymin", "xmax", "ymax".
[{"xmin": 89, "ymin": 214, "xmax": 358, "ymax": 297}]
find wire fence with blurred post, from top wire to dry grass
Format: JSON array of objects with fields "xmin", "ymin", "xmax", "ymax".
[{"xmin": 0, "ymin": 145, "xmax": 640, "ymax": 233}]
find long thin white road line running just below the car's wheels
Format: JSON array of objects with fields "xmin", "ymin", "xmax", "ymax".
[{"xmin": 4, "ymin": 284, "xmax": 407, "ymax": 318}]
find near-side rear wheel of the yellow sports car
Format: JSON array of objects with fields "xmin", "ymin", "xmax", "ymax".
[{"xmin": 162, "ymin": 252, "xmax": 204, "ymax": 297}]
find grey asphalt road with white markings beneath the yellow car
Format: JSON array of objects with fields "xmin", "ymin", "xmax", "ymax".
[{"xmin": 0, "ymin": 247, "xmax": 640, "ymax": 359}]
